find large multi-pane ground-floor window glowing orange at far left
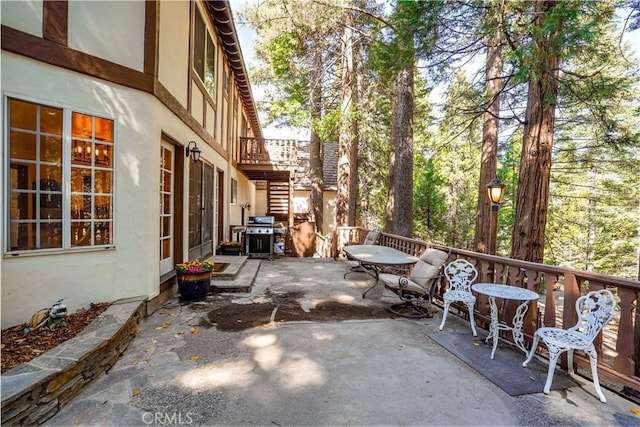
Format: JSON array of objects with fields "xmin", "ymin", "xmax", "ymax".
[{"xmin": 5, "ymin": 98, "xmax": 114, "ymax": 251}]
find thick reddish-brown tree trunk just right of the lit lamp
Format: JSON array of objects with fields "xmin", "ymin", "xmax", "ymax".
[{"xmin": 511, "ymin": 0, "xmax": 562, "ymax": 262}]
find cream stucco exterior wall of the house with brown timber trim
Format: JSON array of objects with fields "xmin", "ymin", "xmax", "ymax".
[{"xmin": 0, "ymin": 1, "xmax": 256, "ymax": 328}]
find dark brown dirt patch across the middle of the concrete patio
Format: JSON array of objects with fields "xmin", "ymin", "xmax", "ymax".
[{"xmin": 207, "ymin": 292, "xmax": 397, "ymax": 331}]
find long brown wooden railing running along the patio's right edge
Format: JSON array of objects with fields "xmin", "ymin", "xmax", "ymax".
[{"xmin": 334, "ymin": 227, "xmax": 640, "ymax": 392}]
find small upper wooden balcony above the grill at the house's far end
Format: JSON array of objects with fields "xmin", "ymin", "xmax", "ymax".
[{"xmin": 238, "ymin": 137, "xmax": 298, "ymax": 181}]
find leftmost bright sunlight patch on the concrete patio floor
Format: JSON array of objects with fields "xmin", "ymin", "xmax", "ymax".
[{"xmin": 178, "ymin": 360, "xmax": 258, "ymax": 390}]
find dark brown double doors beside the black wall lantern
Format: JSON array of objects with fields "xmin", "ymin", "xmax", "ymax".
[{"xmin": 189, "ymin": 161, "xmax": 215, "ymax": 260}]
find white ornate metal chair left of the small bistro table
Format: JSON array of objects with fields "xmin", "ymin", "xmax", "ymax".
[{"xmin": 440, "ymin": 259, "xmax": 478, "ymax": 337}]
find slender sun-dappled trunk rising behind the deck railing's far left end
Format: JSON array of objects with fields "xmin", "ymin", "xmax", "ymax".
[{"xmin": 336, "ymin": 10, "xmax": 355, "ymax": 227}]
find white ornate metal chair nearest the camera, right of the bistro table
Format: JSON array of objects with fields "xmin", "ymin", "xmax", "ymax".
[{"xmin": 522, "ymin": 289, "xmax": 616, "ymax": 403}]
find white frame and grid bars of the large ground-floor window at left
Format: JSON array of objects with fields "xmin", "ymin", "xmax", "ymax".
[{"xmin": 1, "ymin": 92, "xmax": 117, "ymax": 257}]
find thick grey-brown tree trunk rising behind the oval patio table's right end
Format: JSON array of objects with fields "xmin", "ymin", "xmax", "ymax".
[{"xmin": 385, "ymin": 65, "xmax": 413, "ymax": 237}]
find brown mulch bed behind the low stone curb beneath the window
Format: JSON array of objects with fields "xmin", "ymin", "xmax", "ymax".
[{"xmin": 2, "ymin": 303, "xmax": 111, "ymax": 372}]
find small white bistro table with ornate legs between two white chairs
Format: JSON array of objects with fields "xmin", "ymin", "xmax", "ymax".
[{"xmin": 471, "ymin": 283, "xmax": 540, "ymax": 359}]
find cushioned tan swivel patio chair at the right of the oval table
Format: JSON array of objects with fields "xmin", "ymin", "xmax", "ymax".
[{"xmin": 379, "ymin": 248, "xmax": 450, "ymax": 318}]
